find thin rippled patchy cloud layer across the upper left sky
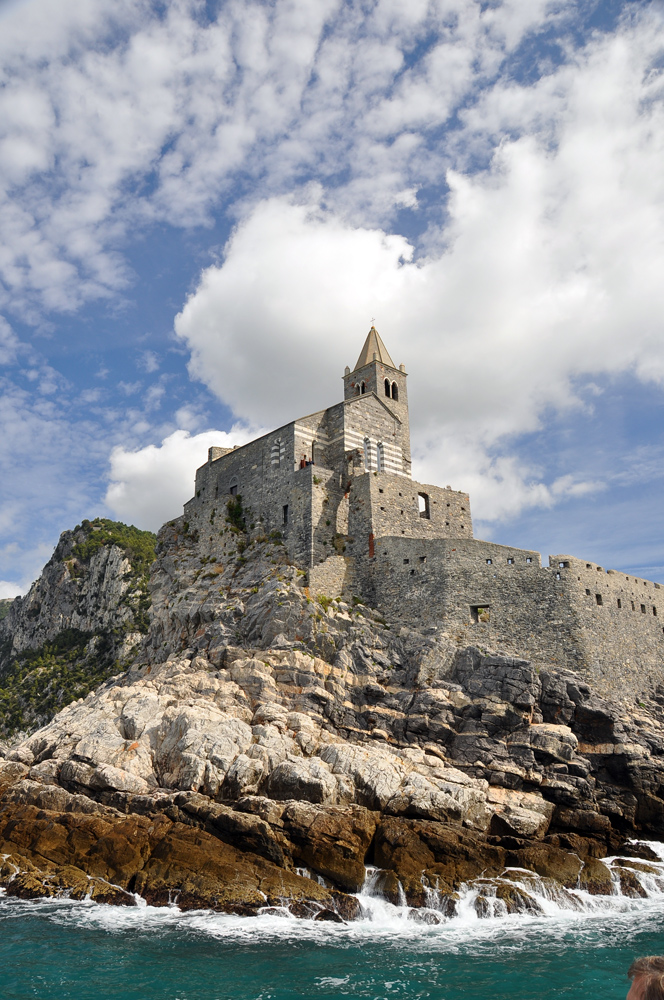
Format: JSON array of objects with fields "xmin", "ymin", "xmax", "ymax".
[{"xmin": 0, "ymin": 0, "xmax": 575, "ymax": 319}]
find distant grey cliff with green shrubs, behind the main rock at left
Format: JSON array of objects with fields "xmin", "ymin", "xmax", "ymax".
[{"xmin": 0, "ymin": 518, "xmax": 156, "ymax": 737}]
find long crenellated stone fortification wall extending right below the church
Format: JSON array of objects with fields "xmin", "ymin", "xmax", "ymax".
[{"xmin": 349, "ymin": 536, "xmax": 664, "ymax": 697}]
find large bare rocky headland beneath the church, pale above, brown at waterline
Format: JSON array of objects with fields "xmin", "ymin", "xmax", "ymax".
[{"xmin": 0, "ymin": 508, "xmax": 664, "ymax": 920}]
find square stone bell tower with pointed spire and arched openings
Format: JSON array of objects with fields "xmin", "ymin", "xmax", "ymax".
[{"xmin": 344, "ymin": 326, "xmax": 410, "ymax": 475}]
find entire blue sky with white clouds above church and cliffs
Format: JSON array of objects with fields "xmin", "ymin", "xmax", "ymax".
[{"xmin": 0, "ymin": 0, "xmax": 664, "ymax": 597}]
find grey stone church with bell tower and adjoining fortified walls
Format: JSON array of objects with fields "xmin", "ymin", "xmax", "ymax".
[{"xmin": 185, "ymin": 327, "xmax": 664, "ymax": 694}]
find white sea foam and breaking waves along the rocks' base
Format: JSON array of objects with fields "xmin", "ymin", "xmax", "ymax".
[{"xmin": 0, "ymin": 842, "xmax": 664, "ymax": 954}]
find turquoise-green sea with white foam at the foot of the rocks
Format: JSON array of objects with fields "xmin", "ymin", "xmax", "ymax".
[{"xmin": 0, "ymin": 843, "xmax": 664, "ymax": 1000}]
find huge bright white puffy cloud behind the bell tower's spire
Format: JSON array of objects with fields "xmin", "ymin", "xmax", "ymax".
[{"xmin": 176, "ymin": 15, "xmax": 664, "ymax": 516}]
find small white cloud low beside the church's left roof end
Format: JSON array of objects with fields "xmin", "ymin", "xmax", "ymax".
[{"xmin": 105, "ymin": 426, "xmax": 254, "ymax": 531}]
